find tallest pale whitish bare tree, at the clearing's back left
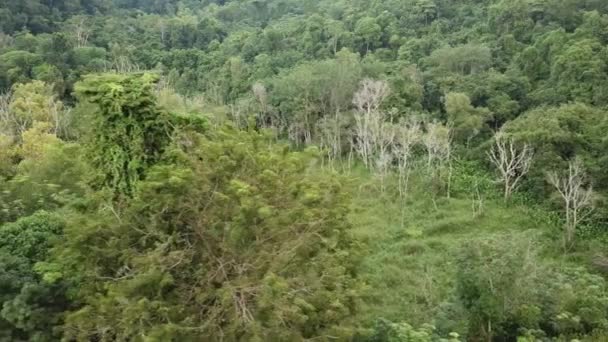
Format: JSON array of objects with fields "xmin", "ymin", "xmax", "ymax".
[{"xmin": 353, "ymin": 79, "xmax": 390, "ymax": 168}]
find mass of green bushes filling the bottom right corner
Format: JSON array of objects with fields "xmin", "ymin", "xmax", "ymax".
[{"xmin": 448, "ymin": 236, "xmax": 608, "ymax": 339}]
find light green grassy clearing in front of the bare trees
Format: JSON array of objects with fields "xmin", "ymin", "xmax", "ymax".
[{"xmin": 350, "ymin": 169, "xmax": 555, "ymax": 325}]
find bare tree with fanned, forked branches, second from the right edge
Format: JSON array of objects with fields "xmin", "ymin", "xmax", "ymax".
[{"xmin": 488, "ymin": 133, "xmax": 534, "ymax": 201}]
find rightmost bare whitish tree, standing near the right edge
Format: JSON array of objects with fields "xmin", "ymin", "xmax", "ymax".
[{"xmin": 547, "ymin": 160, "xmax": 593, "ymax": 251}]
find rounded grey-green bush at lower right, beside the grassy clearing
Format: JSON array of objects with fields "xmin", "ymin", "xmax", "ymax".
[{"xmin": 455, "ymin": 235, "xmax": 550, "ymax": 342}]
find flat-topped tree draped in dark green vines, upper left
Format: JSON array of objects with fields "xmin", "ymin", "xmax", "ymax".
[{"xmin": 76, "ymin": 74, "xmax": 170, "ymax": 197}]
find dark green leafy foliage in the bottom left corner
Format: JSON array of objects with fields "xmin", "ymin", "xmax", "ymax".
[{"xmin": 0, "ymin": 212, "xmax": 69, "ymax": 341}]
